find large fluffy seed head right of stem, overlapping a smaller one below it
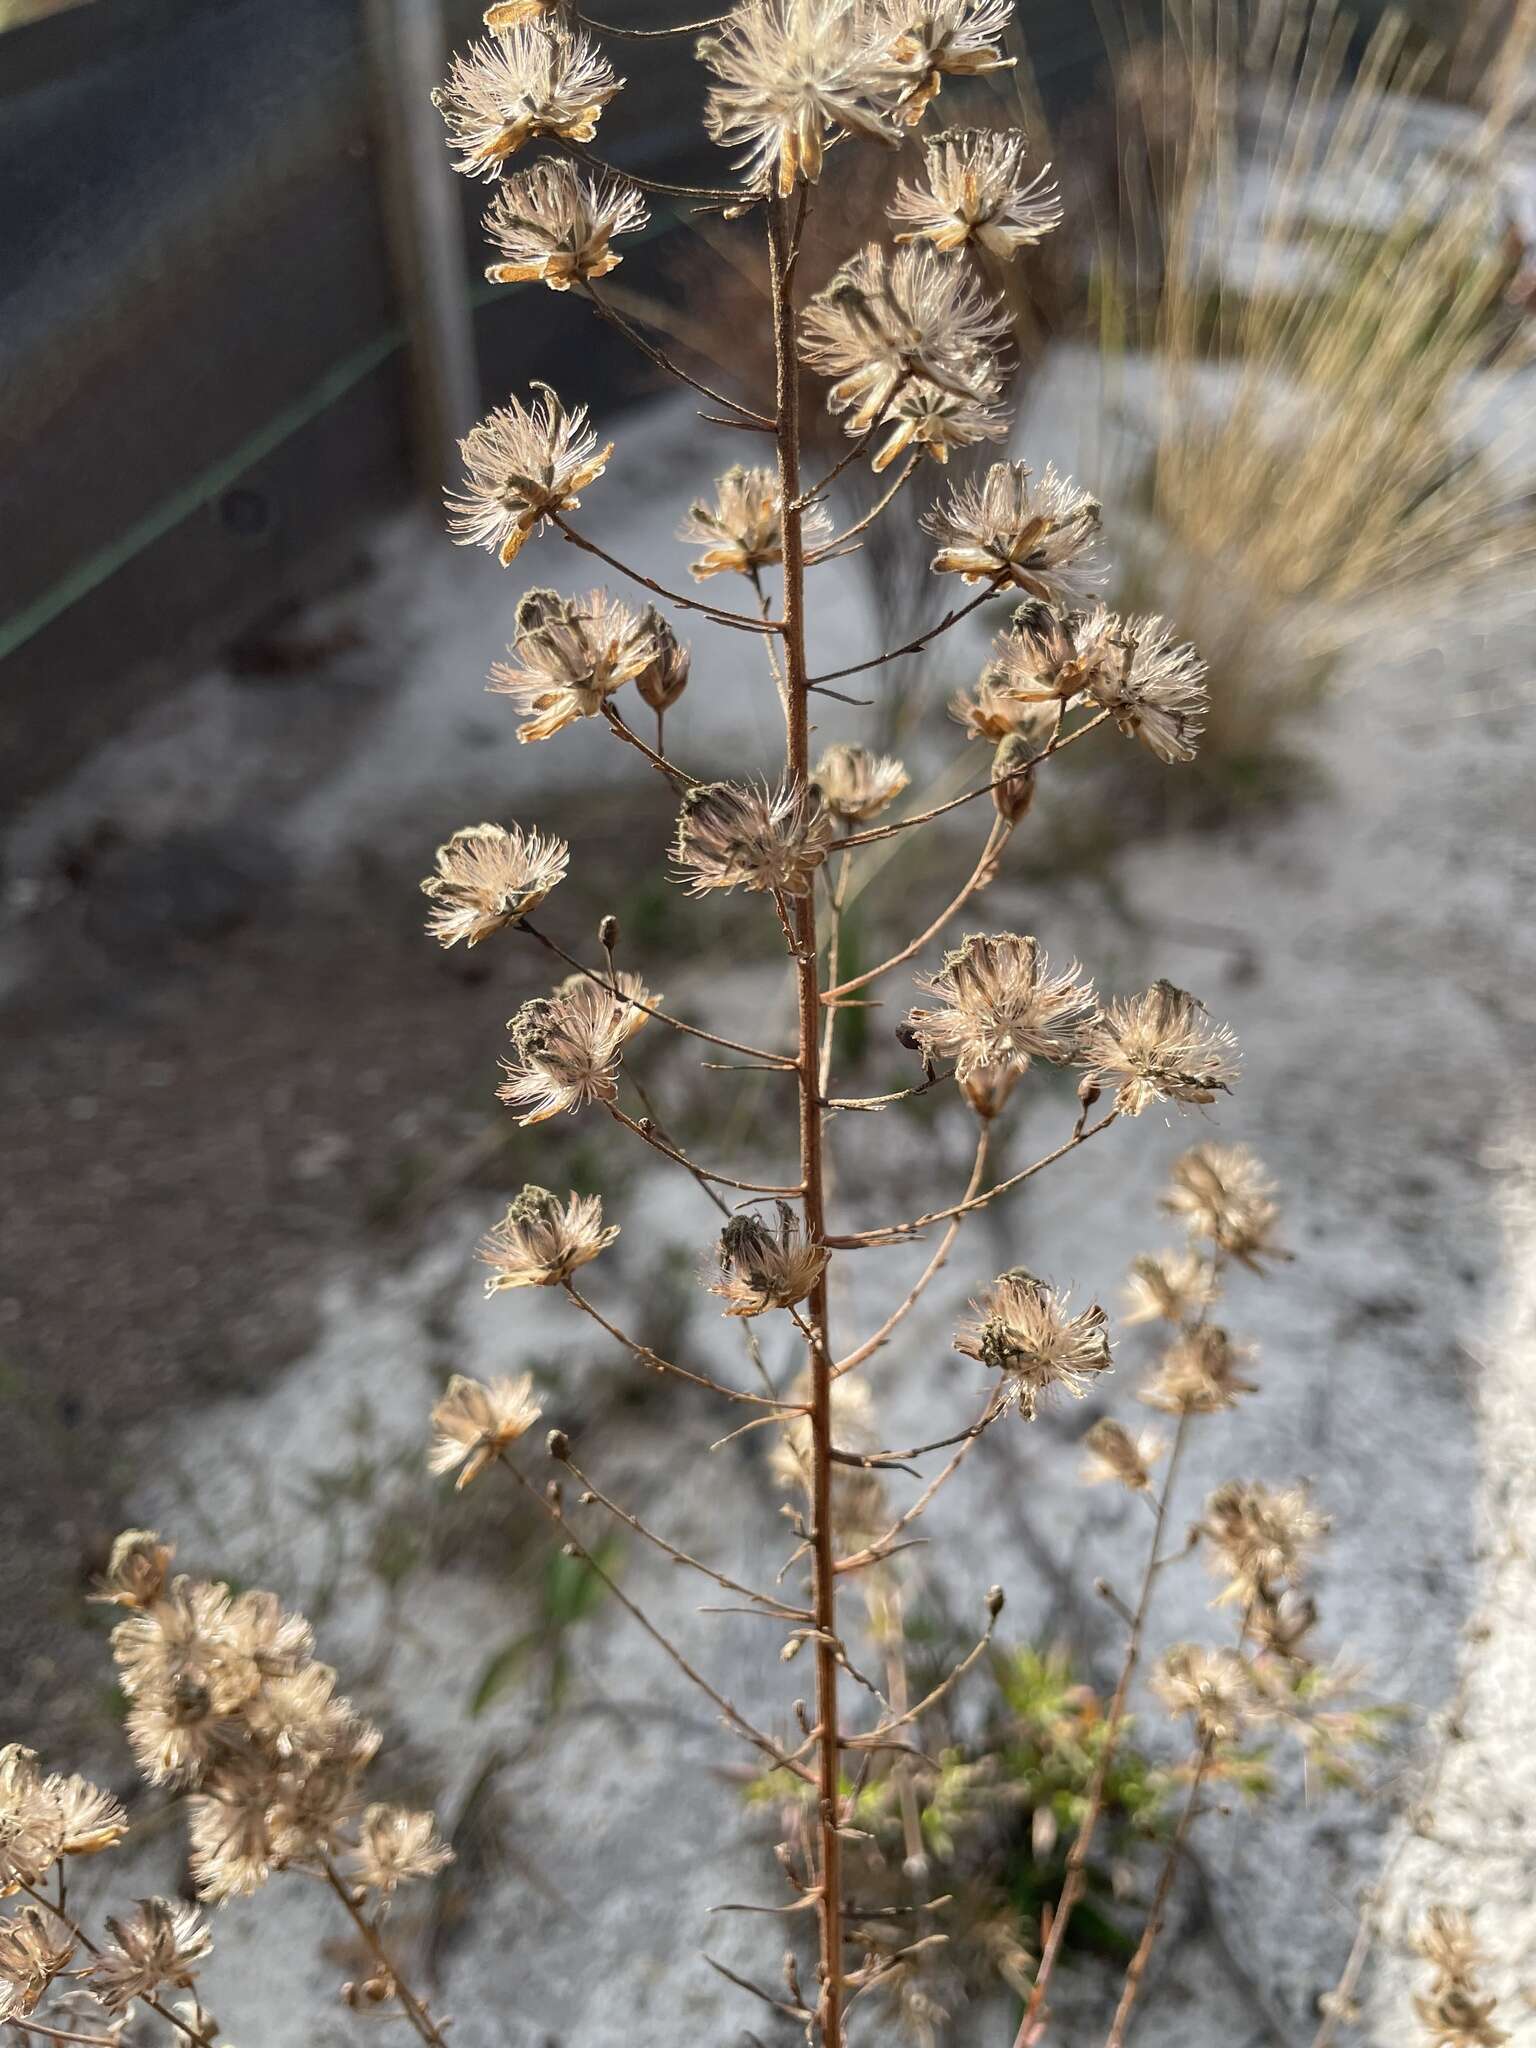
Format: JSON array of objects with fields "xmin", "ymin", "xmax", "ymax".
[{"xmin": 801, "ymin": 242, "xmax": 1008, "ymax": 434}]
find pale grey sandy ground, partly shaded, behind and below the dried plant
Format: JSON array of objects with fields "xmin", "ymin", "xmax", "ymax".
[{"xmin": 0, "ymin": 368, "xmax": 1536, "ymax": 2048}]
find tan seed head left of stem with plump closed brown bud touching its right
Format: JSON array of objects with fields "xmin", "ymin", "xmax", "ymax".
[{"xmin": 485, "ymin": 590, "xmax": 657, "ymax": 745}]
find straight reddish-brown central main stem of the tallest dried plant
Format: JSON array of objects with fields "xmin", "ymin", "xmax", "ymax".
[{"xmin": 766, "ymin": 199, "xmax": 842, "ymax": 2048}]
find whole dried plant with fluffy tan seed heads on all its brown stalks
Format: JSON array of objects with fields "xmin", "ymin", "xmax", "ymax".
[{"xmin": 0, "ymin": 0, "xmax": 1441, "ymax": 2048}]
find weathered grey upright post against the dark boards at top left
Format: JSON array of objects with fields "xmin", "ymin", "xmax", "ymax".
[{"xmin": 362, "ymin": 0, "xmax": 481, "ymax": 500}]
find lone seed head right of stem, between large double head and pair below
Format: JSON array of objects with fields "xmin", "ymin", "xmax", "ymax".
[{"xmin": 924, "ymin": 463, "xmax": 1104, "ymax": 602}]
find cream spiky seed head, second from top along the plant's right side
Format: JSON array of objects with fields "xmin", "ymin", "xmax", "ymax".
[{"xmin": 891, "ymin": 129, "xmax": 1061, "ymax": 262}]
